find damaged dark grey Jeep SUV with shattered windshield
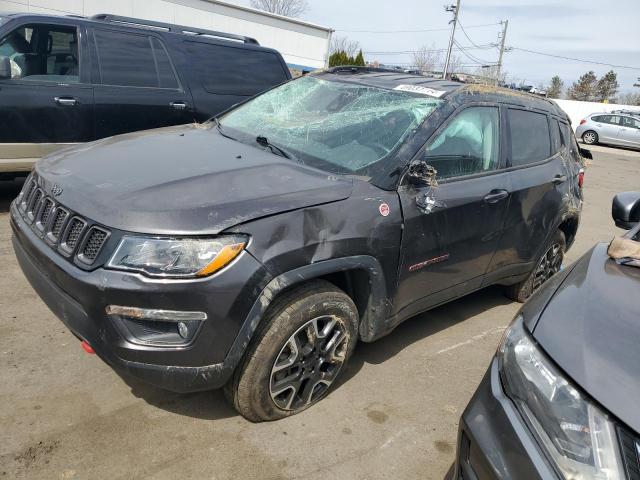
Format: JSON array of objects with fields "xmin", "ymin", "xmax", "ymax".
[{"xmin": 11, "ymin": 67, "xmax": 582, "ymax": 421}]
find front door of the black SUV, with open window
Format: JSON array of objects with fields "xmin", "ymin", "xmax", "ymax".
[{"xmin": 0, "ymin": 19, "xmax": 93, "ymax": 171}]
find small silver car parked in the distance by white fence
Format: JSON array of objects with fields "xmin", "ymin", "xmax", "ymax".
[{"xmin": 576, "ymin": 113, "xmax": 640, "ymax": 148}]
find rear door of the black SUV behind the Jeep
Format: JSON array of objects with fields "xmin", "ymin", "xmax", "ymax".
[{"xmin": 91, "ymin": 27, "xmax": 194, "ymax": 138}]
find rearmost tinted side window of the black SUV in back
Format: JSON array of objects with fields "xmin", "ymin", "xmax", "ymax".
[{"xmin": 187, "ymin": 42, "xmax": 288, "ymax": 96}]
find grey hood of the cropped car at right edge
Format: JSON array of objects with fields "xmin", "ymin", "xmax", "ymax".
[{"xmin": 533, "ymin": 244, "xmax": 640, "ymax": 432}]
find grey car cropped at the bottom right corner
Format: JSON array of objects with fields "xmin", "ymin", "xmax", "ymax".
[{"xmin": 454, "ymin": 192, "xmax": 640, "ymax": 480}]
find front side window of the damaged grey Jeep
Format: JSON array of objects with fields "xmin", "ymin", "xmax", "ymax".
[{"xmin": 424, "ymin": 107, "xmax": 500, "ymax": 179}]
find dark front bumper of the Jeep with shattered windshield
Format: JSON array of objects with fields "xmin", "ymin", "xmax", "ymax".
[{"xmin": 11, "ymin": 201, "xmax": 268, "ymax": 392}]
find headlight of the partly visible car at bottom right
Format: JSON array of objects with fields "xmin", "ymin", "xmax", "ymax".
[{"xmin": 498, "ymin": 317, "xmax": 625, "ymax": 480}]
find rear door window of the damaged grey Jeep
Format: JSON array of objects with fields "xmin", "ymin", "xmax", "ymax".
[{"xmin": 509, "ymin": 109, "xmax": 551, "ymax": 167}]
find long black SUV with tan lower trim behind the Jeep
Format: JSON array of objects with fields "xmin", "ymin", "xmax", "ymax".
[{"xmin": 0, "ymin": 14, "xmax": 291, "ymax": 176}]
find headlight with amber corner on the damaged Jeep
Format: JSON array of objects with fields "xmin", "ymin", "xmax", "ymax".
[{"xmin": 107, "ymin": 236, "xmax": 247, "ymax": 278}]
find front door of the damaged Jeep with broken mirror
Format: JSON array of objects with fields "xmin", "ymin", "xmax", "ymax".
[{"xmin": 395, "ymin": 105, "xmax": 510, "ymax": 311}]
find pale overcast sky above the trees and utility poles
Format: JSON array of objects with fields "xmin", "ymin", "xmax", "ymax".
[{"xmin": 232, "ymin": 0, "xmax": 640, "ymax": 92}]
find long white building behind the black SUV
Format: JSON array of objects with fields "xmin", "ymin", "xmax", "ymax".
[{"xmin": 0, "ymin": 0, "xmax": 333, "ymax": 70}]
